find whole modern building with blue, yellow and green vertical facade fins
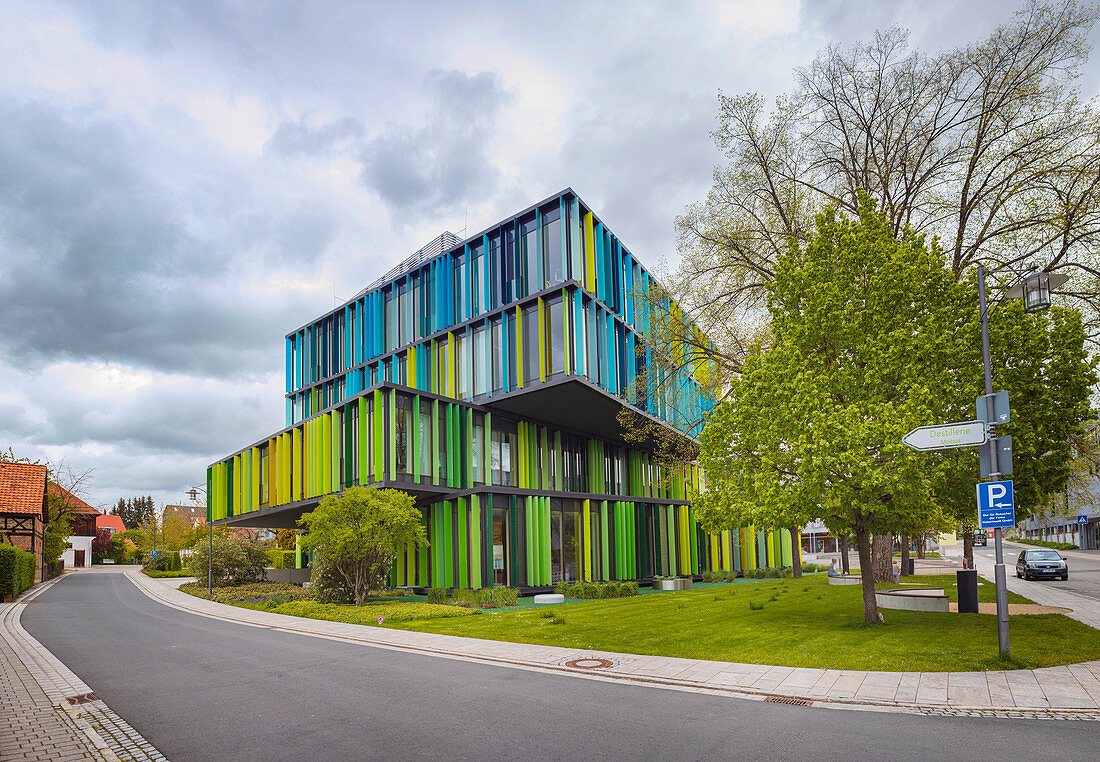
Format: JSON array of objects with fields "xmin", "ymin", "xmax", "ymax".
[{"xmin": 207, "ymin": 190, "xmax": 798, "ymax": 588}]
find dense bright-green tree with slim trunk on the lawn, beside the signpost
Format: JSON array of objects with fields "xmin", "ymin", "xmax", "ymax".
[{"xmin": 696, "ymin": 194, "xmax": 977, "ymax": 622}]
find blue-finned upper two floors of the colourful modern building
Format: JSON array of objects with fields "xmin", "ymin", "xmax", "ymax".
[{"xmin": 279, "ymin": 189, "xmax": 713, "ymax": 434}]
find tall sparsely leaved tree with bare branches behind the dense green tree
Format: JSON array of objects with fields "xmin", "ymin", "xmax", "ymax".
[{"xmin": 667, "ymin": 0, "xmax": 1100, "ymax": 365}]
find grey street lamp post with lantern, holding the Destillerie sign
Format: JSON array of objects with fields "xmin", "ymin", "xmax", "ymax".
[{"xmin": 978, "ymin": 265, "xmax": 1068, "ymax": 653}]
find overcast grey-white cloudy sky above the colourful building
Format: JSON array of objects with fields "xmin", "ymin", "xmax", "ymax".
[{"xmin": 0, "ymin": 0, "xmax": 1100, "ymax": 505}]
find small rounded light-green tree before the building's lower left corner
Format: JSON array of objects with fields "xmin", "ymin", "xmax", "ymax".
[{"xmin": 298, "ymin": 487, "xmax": 427, "ymax": 606}]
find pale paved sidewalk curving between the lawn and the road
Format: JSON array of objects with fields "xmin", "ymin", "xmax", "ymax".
[{"xmin": 127, "ymin": 571, "xmax": 1100, "ymax": 720}]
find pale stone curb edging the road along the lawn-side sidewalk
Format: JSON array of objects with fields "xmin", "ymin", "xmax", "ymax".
[{"xmin": 125, "ymin": 571, "xmax": 1100, "ymax": 721}]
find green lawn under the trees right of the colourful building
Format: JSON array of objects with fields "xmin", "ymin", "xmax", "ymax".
[{"xmin": 387, "ymin": 575, "xmax": 1100, "ymax": 672}]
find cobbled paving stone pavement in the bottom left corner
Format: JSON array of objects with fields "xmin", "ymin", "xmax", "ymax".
[{"xmin": 0, "ymin": 572, "xmax": 165, "ymax": 762}]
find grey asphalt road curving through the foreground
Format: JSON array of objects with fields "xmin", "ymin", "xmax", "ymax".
[{"xmin": 22, "ymin": 572, "xmax": 1100, "ymax": 762}]
